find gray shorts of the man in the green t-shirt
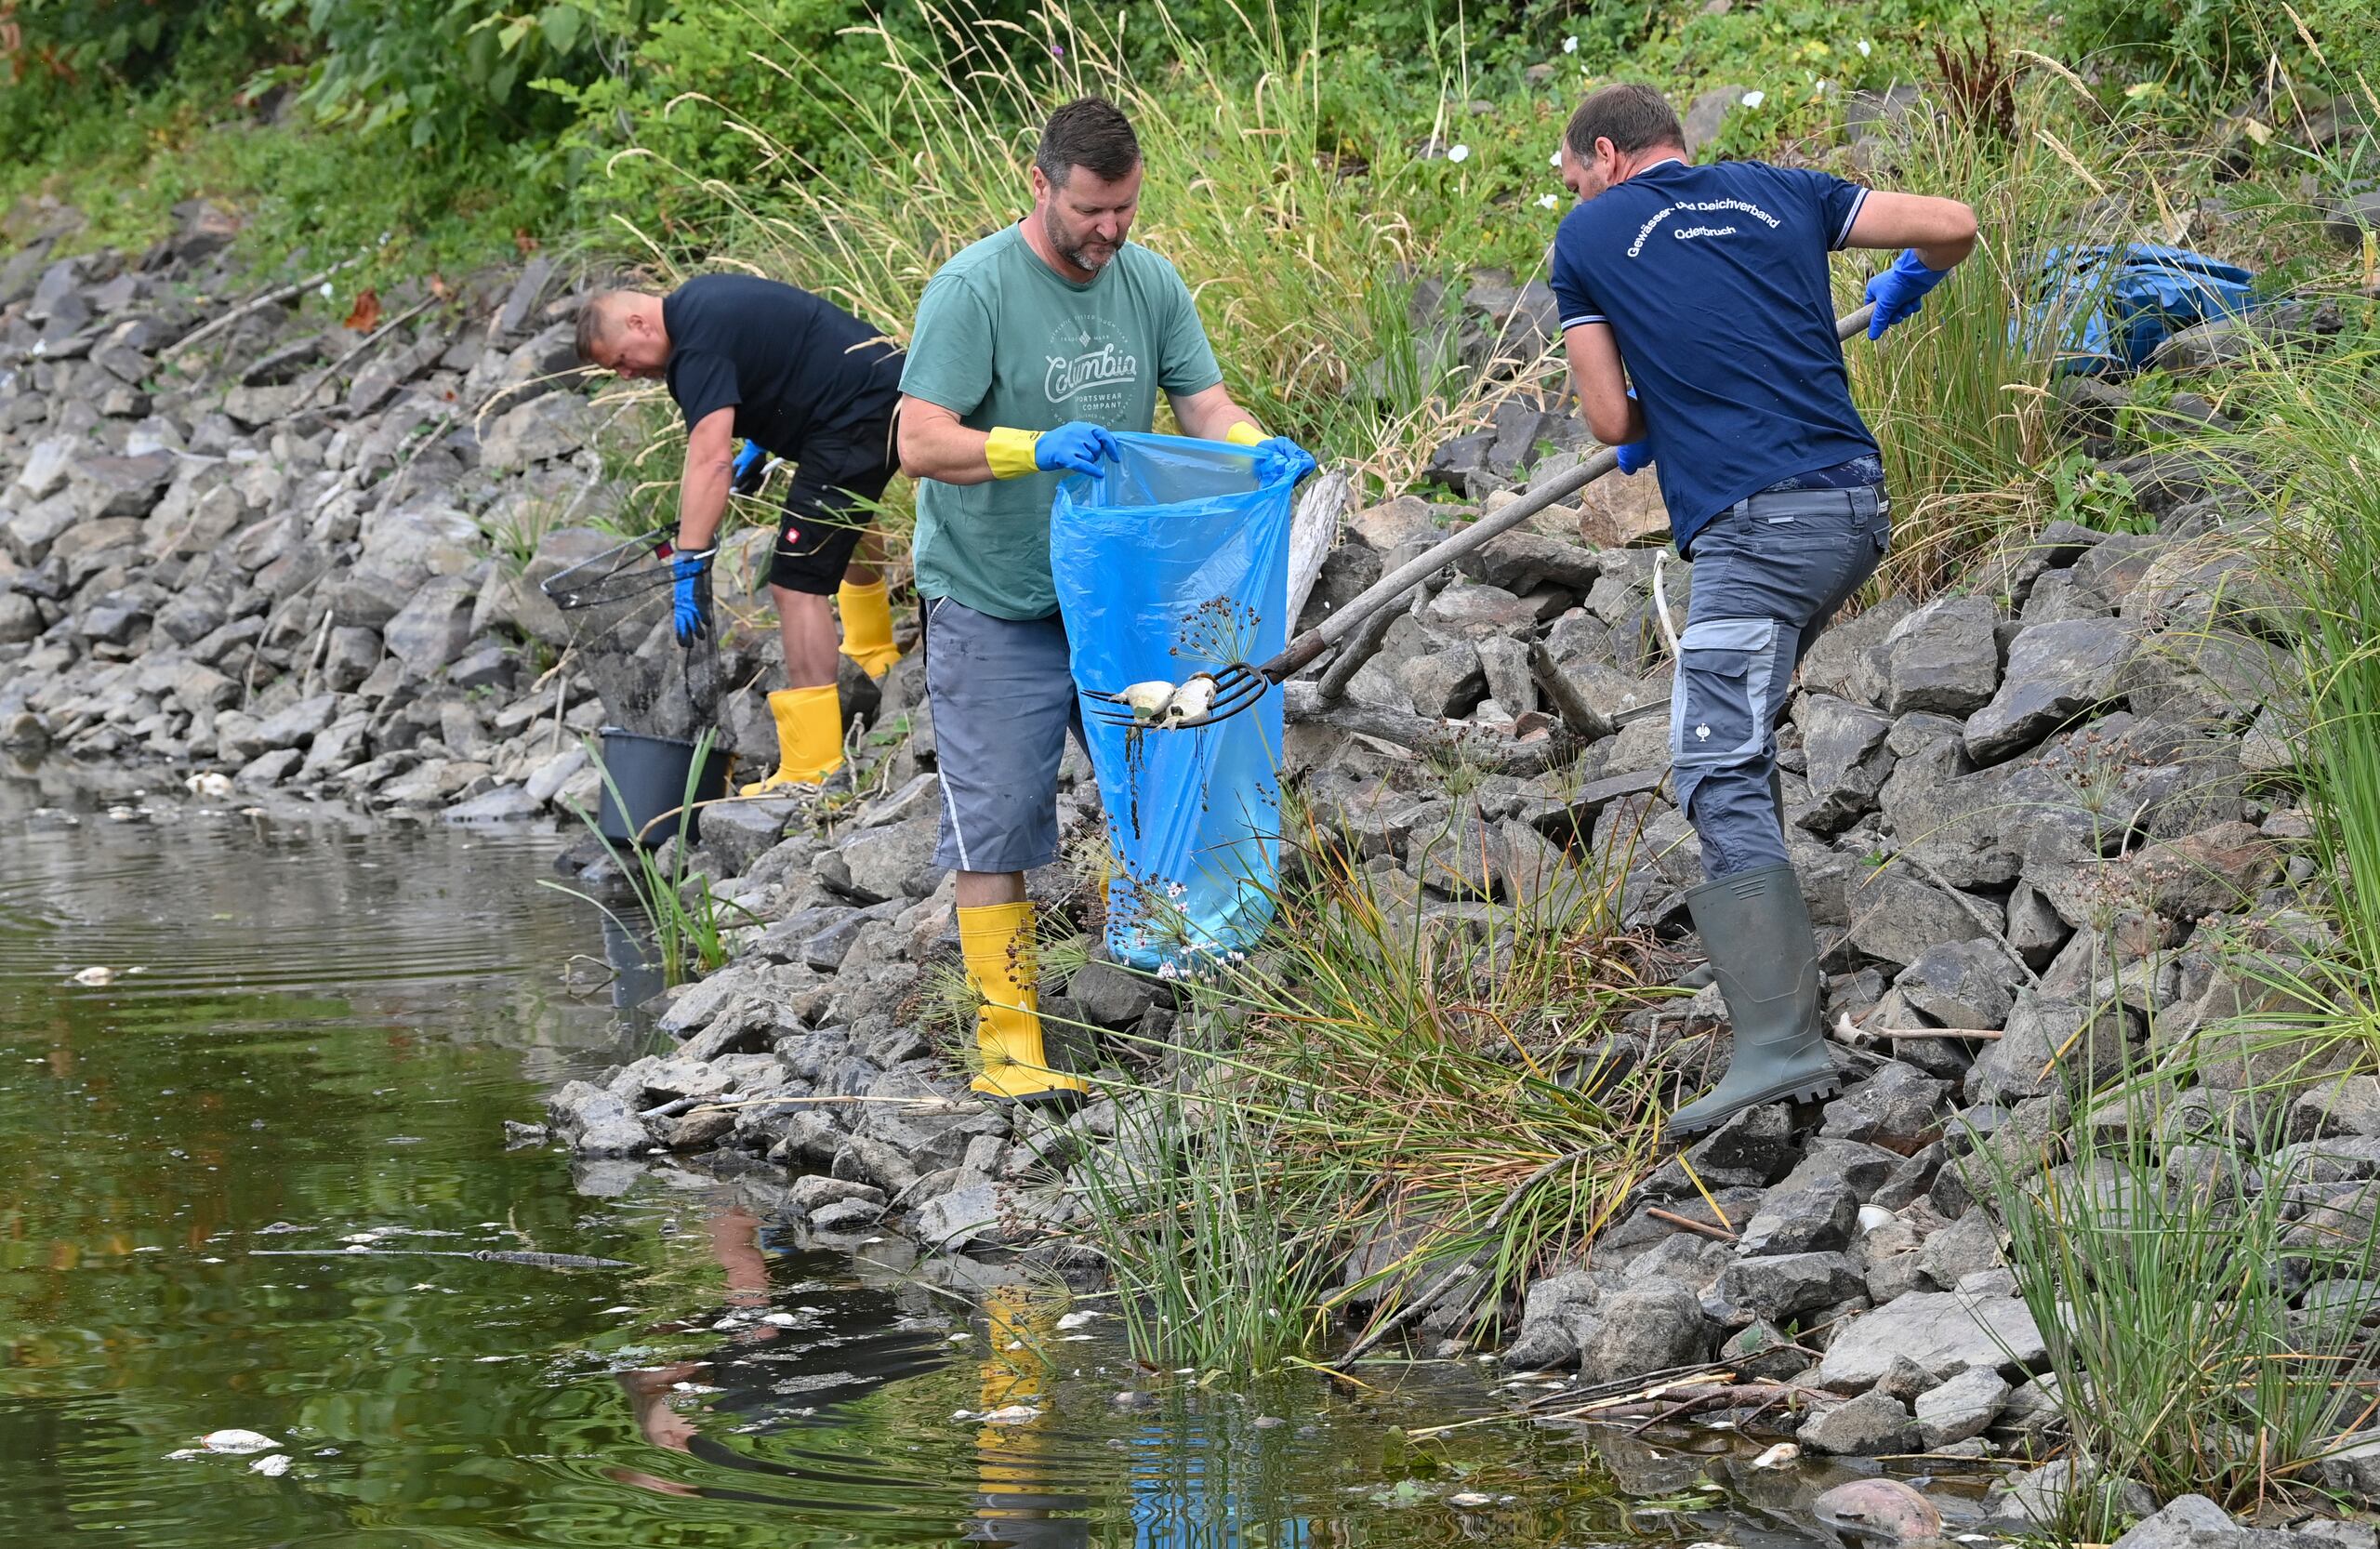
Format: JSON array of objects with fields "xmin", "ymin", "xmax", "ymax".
[{"xmin": 926, "ymin": 597, "xmax": 1083, "ymax": 871}]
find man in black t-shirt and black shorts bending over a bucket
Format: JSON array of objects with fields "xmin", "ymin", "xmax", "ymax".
[{"xmin": 578, "ymin": 273, "xmax": 902, "ymax": 795}]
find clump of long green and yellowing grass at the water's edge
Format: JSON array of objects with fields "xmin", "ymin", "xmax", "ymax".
[{"xmin": 1061, "ymin": 803, "xmax": 1666, "ymax": 1373}]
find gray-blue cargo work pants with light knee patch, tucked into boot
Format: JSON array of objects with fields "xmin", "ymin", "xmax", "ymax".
[{"xmin": 1669, "ymin": 485, "xmax": 1892, "ymax": 878}]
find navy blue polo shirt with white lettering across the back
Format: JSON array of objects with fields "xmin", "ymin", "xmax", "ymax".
[{"xmin": 1552, "ymin": 162, "xmax": 1875, "ymax": 554}]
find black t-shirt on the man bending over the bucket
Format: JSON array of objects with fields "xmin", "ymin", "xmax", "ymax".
[{"xmin": 662, "ymin": 273, "xmax": 902, "ymax": 461}]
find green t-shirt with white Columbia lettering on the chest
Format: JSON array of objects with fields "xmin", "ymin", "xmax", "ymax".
[{"xmin": 900, "ymin": 226, "xmax": 1223, "ymax": 618}]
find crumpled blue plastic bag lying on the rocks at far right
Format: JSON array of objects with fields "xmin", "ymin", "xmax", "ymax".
[{"xmin": 2009, "ymin": 243, "xmax": 2256, "ymax": 374}]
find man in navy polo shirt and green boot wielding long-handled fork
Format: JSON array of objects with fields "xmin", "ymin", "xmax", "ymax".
[{"xmin": 1552, "ymin": 86, "xmax": 1976, "ymax": 1135}]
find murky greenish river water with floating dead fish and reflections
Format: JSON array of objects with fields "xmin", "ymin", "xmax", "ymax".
[{"xmin": 0, "ymin": 769, "xmax": 1856, "ymax": 1549}]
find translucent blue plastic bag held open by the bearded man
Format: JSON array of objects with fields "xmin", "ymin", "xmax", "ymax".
[{"xmin": 1050, "ymin": 435, "xmax": 1292, "ymax": 969}]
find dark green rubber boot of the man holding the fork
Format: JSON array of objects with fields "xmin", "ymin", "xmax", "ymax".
[{"xmin": 1669, "ymin": 867, "xmax": 1842, "ymax": 1137}]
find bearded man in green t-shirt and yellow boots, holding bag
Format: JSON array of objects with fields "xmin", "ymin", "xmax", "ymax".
[{"xmin": 900, "ymin": 98, "xmax": 1314, "ymax": 1099}]
